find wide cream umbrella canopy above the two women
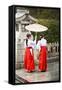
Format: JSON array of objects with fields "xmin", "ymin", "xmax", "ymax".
[{"xmin": 25, "ymin": 23, "xmax": 48, "ymax": 32}]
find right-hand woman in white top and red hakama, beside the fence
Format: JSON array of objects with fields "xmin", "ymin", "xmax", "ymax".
[{"xmin": 38, "ymin": 36, "xmax": 47, "ymax": 71}]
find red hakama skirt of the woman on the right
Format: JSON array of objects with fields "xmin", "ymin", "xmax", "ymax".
[{"xmin": 39, "ymin": 46, "xmax": 47, "ymax": 71}]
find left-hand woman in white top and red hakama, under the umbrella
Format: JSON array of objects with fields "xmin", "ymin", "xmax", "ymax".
[{"xmin": 24, "ymin": 34, "xmax": 35, "ymax": 72}]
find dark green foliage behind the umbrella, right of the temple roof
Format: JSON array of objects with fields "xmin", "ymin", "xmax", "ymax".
[{"xmin": 26, "ymin": 8, "xmax": 60, "ymax": 42}]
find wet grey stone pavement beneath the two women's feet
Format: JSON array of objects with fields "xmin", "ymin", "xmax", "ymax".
[{"xmin": 16, "ymin": 61, "xmax": 59, "ymax": 83}]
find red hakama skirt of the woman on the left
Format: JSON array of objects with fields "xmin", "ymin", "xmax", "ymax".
[{"xmin": 24, "ymin": 47, "xmax": 35, "ymax": 71}]
